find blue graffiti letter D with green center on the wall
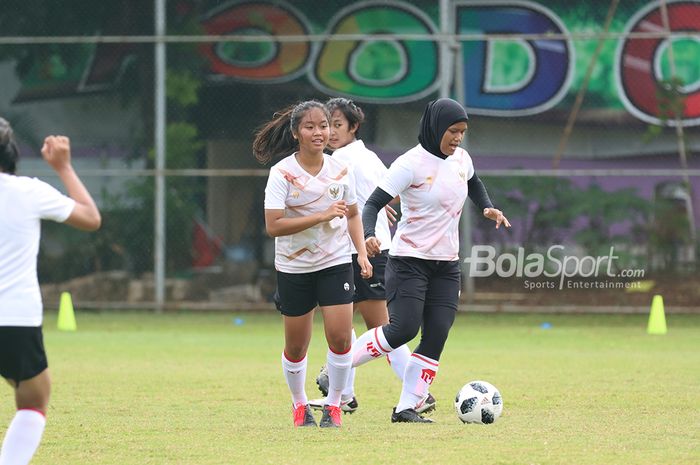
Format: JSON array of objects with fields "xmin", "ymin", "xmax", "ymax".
[{"xmin": 456, "ymin": 1, "xmax": 574, "ymax": 116}]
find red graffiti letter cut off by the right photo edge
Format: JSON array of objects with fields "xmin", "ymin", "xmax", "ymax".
[{"xmin": 615, "ymin": 2, "xmax": 700, "ymax": 126}]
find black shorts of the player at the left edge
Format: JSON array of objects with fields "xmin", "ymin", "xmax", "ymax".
[{"xmin": 0, "ymin": 326, "xmax": 49, "ymax": 384}]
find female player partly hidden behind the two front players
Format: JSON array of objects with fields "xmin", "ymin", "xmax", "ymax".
[{"xmin": 311, "ymin": 98, "xmax": 435, "ymax": 413}]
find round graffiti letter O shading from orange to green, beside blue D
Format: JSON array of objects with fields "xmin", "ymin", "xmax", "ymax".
[{"xmin": 310, "ymin": 2, "xmax": 439, "ymax": 102}]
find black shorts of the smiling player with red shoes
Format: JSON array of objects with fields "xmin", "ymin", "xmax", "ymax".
[{"xmin": 275, "ymin": 263, "xmax": 355, "ymax": 316}]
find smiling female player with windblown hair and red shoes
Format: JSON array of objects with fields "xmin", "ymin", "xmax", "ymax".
[{"xmin": 253, "ymin": 100, "xmax": 372, "ymax": 427}]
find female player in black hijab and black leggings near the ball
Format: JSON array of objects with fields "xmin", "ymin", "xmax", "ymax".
[{"xmin": 353, "ymin": 98, "xmax": 510, "ymax": 423}]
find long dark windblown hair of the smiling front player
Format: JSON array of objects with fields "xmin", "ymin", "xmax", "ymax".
[{"xmin": 253, "ymin": 100, "xmax": 331, "ymax": 165}]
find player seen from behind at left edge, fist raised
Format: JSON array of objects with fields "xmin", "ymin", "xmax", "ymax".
[{"xmin": 0, "ymin": 118, "xmax": 101, "ymax": 465}]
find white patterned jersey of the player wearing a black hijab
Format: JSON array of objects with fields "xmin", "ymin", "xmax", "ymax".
[{"xmin": 379, "ymin": 144, "xmax": 474, "ymax": 261}]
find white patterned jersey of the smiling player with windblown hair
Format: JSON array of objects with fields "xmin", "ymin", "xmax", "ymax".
[{"xmin": 265, "ymin": 154, "xmax": 357, "ymax": 273}]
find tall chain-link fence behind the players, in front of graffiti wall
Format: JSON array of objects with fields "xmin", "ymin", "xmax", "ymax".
[{"xmin": 0, "ymin": 0, "xmax": 700, "ymax": 310}]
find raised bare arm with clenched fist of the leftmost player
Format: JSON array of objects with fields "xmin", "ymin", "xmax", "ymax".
[{"xmin": 41, "ymin": 136, "xmax": 102, "ymax": 231}]
